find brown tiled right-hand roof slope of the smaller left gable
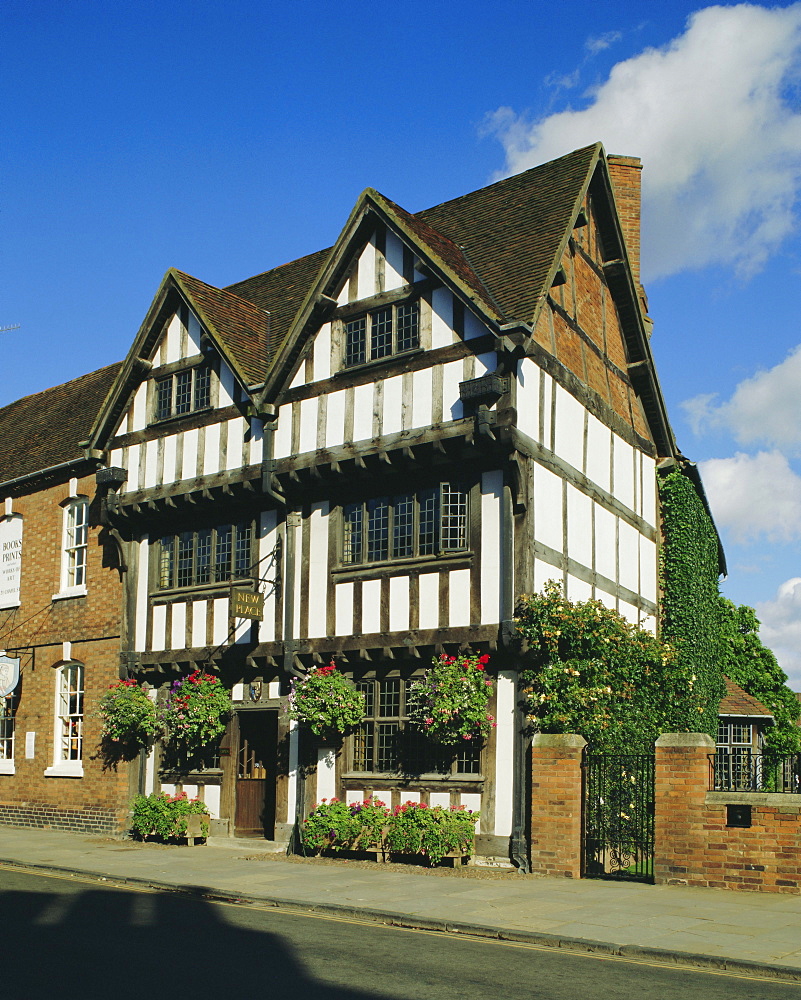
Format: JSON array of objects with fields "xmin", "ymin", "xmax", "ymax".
[{"xmin": 173, "ymin": 270, "xmax": 270, "ymax": 384}]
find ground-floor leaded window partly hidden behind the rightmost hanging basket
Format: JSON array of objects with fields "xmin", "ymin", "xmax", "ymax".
[{"xmin": 352, "ymin": 677, "xmax": 481, "ymax": 774}]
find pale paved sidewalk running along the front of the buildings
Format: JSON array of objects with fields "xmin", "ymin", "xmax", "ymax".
[{"xmin": 0, "ymin": 827, "xmax": 801, "ymax": 981}]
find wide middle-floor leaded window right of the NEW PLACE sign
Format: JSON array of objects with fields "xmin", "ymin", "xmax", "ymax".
[{"xmin": 342, "ymin": 483, "xmax": 467, "ymax": 564}]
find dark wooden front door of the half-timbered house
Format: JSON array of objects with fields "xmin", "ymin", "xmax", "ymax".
[{"xmin": 234, "ymin": 711, "xmax": 278, "ymax": 840}]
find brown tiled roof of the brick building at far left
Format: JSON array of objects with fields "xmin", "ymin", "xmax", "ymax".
[{"xmin": 0, "ymin": 362, "xmax": 121, "ymax": 485}]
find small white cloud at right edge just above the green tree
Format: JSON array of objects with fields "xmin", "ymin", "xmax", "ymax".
[{"xmin": 699, "ymin": 451, "xmax": 801, "ymax": 542}]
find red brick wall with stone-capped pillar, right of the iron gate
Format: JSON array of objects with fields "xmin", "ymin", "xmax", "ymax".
[{"xmin": 654, "ymin": 733, "xmax": 801, "ymax": 893}]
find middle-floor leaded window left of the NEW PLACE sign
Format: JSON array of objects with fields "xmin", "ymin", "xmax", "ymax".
[{"xmin": 159, "ymin": 522, "xmax": 253, "ymax": 590}]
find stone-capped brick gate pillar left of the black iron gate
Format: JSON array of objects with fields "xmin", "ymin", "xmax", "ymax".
[{"xmin": 531, "ymin": 733, "xmax": 587, "ymax": 878}]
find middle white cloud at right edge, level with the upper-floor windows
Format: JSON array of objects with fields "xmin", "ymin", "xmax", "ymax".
[{"xmin": 681, "ymin": 345, "xmax": 801, "ymax": 451}]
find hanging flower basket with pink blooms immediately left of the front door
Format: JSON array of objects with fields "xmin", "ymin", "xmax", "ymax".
[{"xmin": 161, "ymin": 670, "xmax": 232, "ymax": 753}]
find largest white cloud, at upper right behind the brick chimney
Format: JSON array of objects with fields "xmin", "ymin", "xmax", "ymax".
[{"xmin": 488, "ymin": 3, "xmax": 801, "ymax": 278}]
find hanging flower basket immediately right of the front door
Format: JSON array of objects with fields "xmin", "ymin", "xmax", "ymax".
[{"xmin": 287, "ymin": 661, "xmax": 364, "ymax": 738}]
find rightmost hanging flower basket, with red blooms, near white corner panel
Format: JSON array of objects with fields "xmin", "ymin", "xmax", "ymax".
[{"xmin": 409, "ymin": 654, "xmax": 496, "ymax": 745}]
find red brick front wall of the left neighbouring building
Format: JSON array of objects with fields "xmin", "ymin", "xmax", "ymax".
[{"xmin": 0, "ymin": 474, "xmax": 129, "ymax": 832}]
